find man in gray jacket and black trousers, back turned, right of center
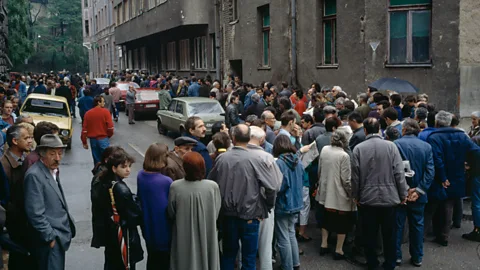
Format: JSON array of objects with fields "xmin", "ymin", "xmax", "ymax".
[{"xmin": 352, "ymin": 118, "xmax": 408, "ymax": 269}]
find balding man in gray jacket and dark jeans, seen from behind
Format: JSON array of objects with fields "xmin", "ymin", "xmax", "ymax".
[{"xmin": 208, "ymin": 124, "xmax": 278, "ymax": 270}]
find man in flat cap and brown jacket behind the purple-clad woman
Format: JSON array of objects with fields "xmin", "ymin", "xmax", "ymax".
[{"xmin": 162, "ymin": 137, "xmax": 197, "ymax": 181}]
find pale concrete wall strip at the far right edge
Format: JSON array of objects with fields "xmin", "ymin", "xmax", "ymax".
[{"xmin": 460, "ymin": 0, "xmax": 480, "ymax": 117}]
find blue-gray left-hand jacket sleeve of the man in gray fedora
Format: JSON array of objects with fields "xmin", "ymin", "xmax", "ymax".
[{"xmin": 24, "ymin": 173, "xmax": 56, "ymax": 243}]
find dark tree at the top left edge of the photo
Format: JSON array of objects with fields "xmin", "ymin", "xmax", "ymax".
[{"xmin": 7, "ymin": 0, "xmax": 33, "ymax": 69}]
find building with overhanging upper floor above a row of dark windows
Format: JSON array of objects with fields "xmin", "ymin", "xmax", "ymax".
[{"xmin": 114, "ymin": 0, "xmax": 219, "ymax": 77}]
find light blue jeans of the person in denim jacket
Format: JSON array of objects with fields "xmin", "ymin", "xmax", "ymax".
[{"xmin": 275, "ymin": 214, "xmax": 300, "ymax": 270}]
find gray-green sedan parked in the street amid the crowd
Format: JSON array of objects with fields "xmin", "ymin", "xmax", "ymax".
[{"xmin": 157, "ymin": 97, "xmax": 225, "ymax": 136}]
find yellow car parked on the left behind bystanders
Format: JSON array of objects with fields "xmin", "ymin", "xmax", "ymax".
[{"xmin": 20, "ymin": 94, "xmax": 73, "ymax": 149}]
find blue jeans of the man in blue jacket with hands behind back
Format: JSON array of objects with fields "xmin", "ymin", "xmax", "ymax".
[{"xmin": 396, "ymin": 203, "xmax": 425, "ymax": 262}]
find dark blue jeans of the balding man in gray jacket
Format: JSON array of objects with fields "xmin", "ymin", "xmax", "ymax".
[{"xmin": 220, "ymin": 217, "xmax": 260, "ymax": 270}]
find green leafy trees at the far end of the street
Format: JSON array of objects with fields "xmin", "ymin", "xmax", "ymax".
[{"xmin": 30, "ymin": 0, "xmax": 88, "ymax": 72}]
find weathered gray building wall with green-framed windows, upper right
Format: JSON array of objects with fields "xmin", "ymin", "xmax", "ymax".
[{"xmin": 220, "ymin": 0, "xmax": 480, "ymax": 116}]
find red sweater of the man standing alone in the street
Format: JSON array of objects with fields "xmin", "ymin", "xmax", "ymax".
[{"xmin": 81, "ymin": 107, "xmax": 114, "ymax": 144}]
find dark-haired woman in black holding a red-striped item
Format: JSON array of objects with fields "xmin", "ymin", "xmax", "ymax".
[{"xmin": 96, "ymin": 150, "xmax": 143, "ymax": 270}]
